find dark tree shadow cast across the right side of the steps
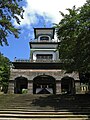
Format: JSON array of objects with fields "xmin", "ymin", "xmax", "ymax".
[{"xmin": 32, "ymin": 94, "xmax": 90, "ymax": 118}]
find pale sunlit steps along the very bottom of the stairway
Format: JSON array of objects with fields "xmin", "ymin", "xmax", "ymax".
[{"xmin": 0, "ymin": 110, "xmax": 90, "ymax": 120}]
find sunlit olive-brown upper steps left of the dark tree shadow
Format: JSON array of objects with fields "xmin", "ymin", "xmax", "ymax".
[{"xmin": 0, "ymin": 94, "xmax": 49, "ymax": 110}]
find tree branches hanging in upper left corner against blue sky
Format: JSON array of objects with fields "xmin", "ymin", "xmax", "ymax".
[{"xmin": 0, "ymin": 0, "xmax": 24, "ymax": 46}]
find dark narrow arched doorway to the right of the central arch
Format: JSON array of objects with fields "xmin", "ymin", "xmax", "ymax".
[{"xmin": 61, "ymin": 76, "xmax": 75, "ymax": 94}]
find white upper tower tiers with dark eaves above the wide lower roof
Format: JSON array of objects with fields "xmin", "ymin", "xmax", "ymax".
[{"xmin": 30, "ymin": 28, "xmax": 59, "ymax": 61}]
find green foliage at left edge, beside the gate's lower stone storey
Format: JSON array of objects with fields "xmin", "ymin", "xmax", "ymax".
[{"xmin": 0, "ymin": 53, "xmax": 10, "ymax": 93}]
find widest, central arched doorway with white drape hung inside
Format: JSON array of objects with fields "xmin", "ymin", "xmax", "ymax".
[{"xmin": 33, "ymin": 75, "xmax": 56, "ymax": 94}]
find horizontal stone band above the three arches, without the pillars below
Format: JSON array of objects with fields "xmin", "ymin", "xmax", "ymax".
[{"xmin": 10, "ymin": 69, "xmax": 79, "ymax": 80}]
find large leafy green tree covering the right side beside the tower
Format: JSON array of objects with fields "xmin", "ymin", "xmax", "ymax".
[{"xmin": 55, "ymin": 0, "xmax": 90, "ymax": 72}]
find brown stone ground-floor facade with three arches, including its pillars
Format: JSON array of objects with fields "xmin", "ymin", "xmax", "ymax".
[{"xmin": 8, "ymin": 69, "xmax": 80, "ymax": 94}]
